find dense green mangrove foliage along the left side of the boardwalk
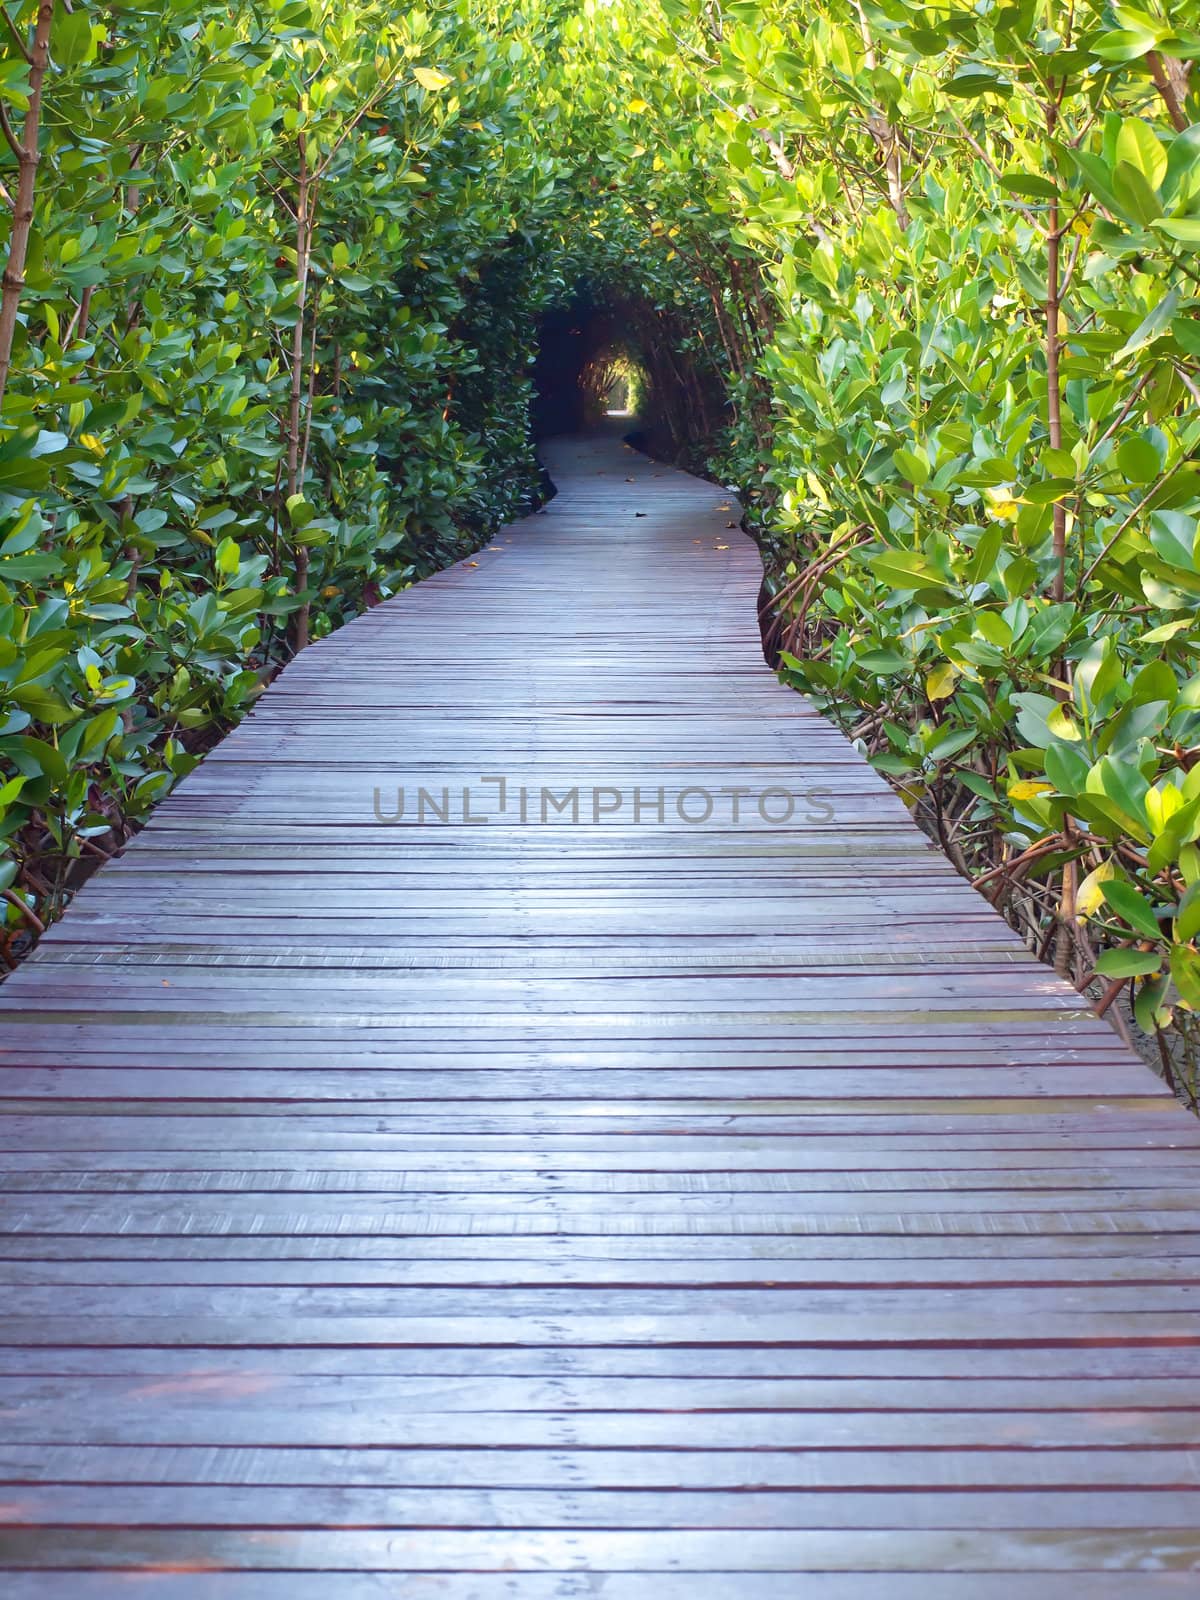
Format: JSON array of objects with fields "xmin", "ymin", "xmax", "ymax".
[{"xmin": 0, "ymin": 0, "xmax": 563, "ymax": 950}]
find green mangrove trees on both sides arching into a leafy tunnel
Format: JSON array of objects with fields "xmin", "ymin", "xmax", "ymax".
[{"xmin": 0, "ymin": 0, "xmax": 1200, "ymax": 1075}]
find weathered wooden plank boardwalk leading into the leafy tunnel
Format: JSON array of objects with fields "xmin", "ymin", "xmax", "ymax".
[{"xmin": 0, "ymin": 438, "xmax": 1200, "ymax": 1600}]
